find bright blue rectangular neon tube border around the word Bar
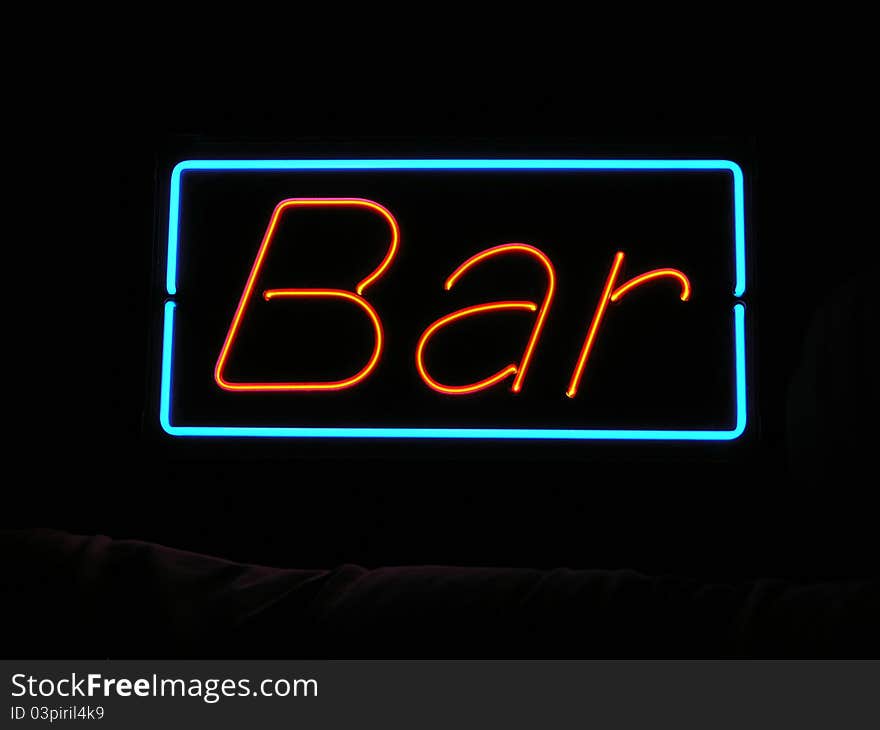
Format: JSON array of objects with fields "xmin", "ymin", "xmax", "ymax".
[{"xmin": 159, "ymin": 159, "xmax": 747, "ymax": 441}]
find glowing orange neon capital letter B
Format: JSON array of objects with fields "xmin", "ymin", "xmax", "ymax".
[{"xmin": 214, "ymin": 198, "xmax": 400, "ymax": 392}]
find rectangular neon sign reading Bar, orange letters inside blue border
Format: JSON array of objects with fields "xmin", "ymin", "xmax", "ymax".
[{"xmin": 159, "ymin": 160, "xmax": 747, "ymax": 441}]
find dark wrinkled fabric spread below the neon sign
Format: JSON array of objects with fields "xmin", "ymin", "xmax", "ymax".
[{"xmin": 0, "ymin": 530, "xmax": 880, "ymax": 658}]
